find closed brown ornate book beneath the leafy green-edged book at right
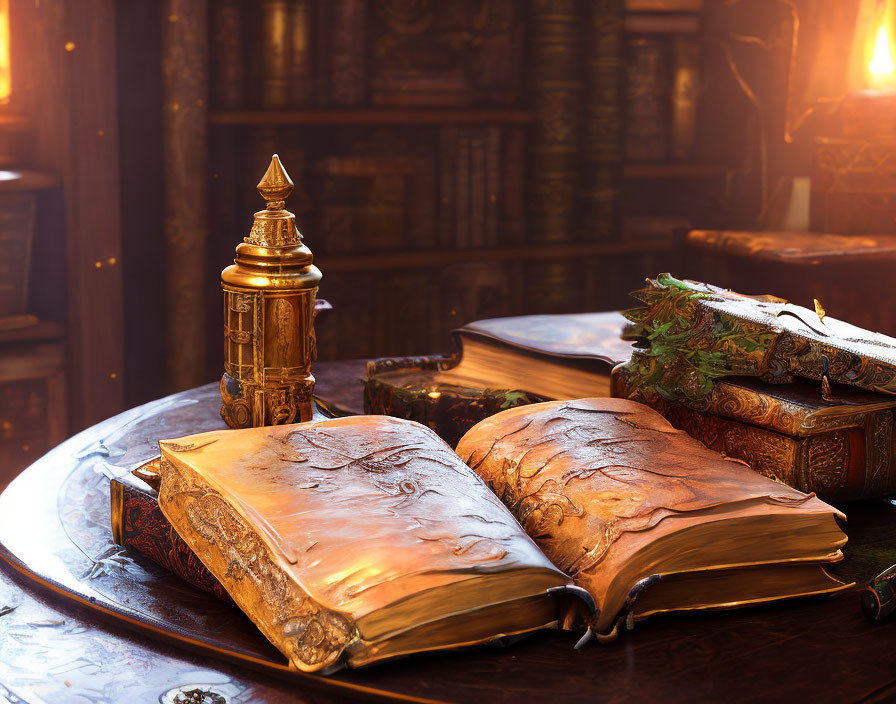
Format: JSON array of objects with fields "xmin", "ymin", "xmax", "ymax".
[{"xmin": 612, "ymin": 365, "xmax": 896, "ymax": 501}]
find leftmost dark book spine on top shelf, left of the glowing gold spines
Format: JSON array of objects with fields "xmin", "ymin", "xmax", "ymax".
[{"xmin": 212, "ymin": 0, "xmax": 246, "ymax": 108}]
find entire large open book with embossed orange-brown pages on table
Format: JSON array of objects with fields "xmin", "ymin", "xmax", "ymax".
[{"xmin": 159, "ymin": 399, "xmax": 847, "ymax": 671}]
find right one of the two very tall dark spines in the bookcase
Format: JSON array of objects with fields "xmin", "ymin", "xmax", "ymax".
[{"xmin": 581, "ymin": 0, "xmax": 625, "ymax": 240}]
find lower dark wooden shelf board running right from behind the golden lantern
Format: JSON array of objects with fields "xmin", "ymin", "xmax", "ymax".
[{"xmin": 315, "ymin": 238, "xmax": 673, "ymax": 274}]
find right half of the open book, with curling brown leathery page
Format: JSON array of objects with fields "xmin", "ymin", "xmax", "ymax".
[{"xmin": 457, "ymin": 398, "xmax": 848, "ymax": 634}]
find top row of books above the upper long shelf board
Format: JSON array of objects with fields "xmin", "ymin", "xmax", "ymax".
[{"xmin": 210, "ymin": 0, "xmax": 525, "ymax": 109}]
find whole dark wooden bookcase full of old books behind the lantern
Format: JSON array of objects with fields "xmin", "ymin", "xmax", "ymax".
[{"xmin": 159, "ymin": 0, "xmax": 729, "ymax": 380}]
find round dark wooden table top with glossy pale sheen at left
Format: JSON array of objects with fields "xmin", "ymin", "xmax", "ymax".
[{"xmin": 0, "ymin": 363, "xmax": 896, "ymax": 704}]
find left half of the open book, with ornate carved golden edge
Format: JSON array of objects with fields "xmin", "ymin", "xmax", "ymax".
[{"xmin": 159, "ymin": 416, "xmax": 587, "ymax": 671}]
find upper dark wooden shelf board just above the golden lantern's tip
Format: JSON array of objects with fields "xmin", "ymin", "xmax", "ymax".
[{"xmin": 208, "ymin": 108, "xmax": 533, "ymax": 126}]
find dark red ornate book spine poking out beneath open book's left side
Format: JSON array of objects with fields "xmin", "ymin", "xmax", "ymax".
[{"xmin": 110, "ymin": 479, "xmax": 233, "ymax": 603}]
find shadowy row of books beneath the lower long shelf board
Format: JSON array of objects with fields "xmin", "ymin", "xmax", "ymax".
[{"xmin": 315, "ymin": 253, "xmax": 668, "ymax": 360}]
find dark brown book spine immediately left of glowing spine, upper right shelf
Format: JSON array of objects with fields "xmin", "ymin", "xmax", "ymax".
[{"xmin": 625, "ymin": 37, "xmax": 669, "ymax": 161}]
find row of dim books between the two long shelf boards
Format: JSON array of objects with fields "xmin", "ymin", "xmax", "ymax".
[{"xmin": 222, "ymin": 125, "xmax": 687, "ymax": 255}]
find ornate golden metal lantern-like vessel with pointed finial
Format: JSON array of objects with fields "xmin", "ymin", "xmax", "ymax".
[{"xmin": 221, "ymin": 154, "xmax": 321, "ymax": 428}]
